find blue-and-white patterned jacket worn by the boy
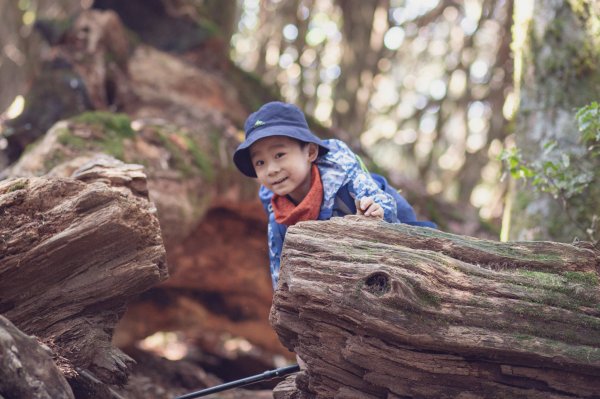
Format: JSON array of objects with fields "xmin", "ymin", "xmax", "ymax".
[{"xmin": 258, "ymin": 139, "xmax": 436, "ymax": 289}]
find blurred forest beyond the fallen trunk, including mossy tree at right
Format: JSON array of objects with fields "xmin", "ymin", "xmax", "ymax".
[{"xmin": 0, "ymin": 0, "xmax": 600, "ymax": 245}]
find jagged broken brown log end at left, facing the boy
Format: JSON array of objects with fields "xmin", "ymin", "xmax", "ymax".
[{"xmin": 0, "ymin": 157, "xmax": 167, "ymax": 397}]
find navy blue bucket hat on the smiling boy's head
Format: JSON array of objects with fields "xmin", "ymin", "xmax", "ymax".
[{"xmin": 233, "ymin": 101, "xmax": 329, "ymax": 177}]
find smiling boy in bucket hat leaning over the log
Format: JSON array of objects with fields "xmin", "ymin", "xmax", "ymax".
[{"xmin": 233, "ymin": 101, "xmax": 435, "ymax": 289}]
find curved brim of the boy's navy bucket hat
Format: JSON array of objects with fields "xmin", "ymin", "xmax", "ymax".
[{"xmin": 233, "ymin": 125, "xmax": 329, "ymax": 177}]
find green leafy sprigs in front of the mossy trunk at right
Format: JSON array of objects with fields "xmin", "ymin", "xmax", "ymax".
[{"xmin": 501, "ymin": 102, "xmax": 600, "ymax": 243}]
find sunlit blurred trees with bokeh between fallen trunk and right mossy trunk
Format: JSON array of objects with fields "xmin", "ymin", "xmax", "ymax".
[{"xmin": 232, "ymin": 0, "xmax": 513, "ymax": 231}]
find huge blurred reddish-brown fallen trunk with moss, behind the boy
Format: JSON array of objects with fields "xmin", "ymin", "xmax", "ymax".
[{"xmin": 0, "ymin": 7, "xmax": 290, "ymax": 384}]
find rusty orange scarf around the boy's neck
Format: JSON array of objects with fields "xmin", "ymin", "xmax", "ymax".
[{"xmin": 271, "ymin": 164, "xmax": 323, "ymax": 226}]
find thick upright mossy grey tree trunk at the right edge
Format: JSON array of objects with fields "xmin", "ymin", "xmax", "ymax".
[{"xmin": 503, "ymin": 0, "xmax": 600, "ymax": 242}]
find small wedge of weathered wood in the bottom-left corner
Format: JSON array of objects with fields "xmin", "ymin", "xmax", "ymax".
[{"xmin": 0, "ymin": 316, "xmax": 74, "ymax": 399}]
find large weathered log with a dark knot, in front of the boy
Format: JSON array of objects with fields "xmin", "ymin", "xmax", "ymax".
[{"xmin": 271, "ymin": 217, "xmax": 600, "ymax": 398}]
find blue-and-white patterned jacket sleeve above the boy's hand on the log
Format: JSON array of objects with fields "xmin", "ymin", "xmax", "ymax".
[{"xmin": 337, "ymin": 141, "xmax": 398, "ymax": 223}]
